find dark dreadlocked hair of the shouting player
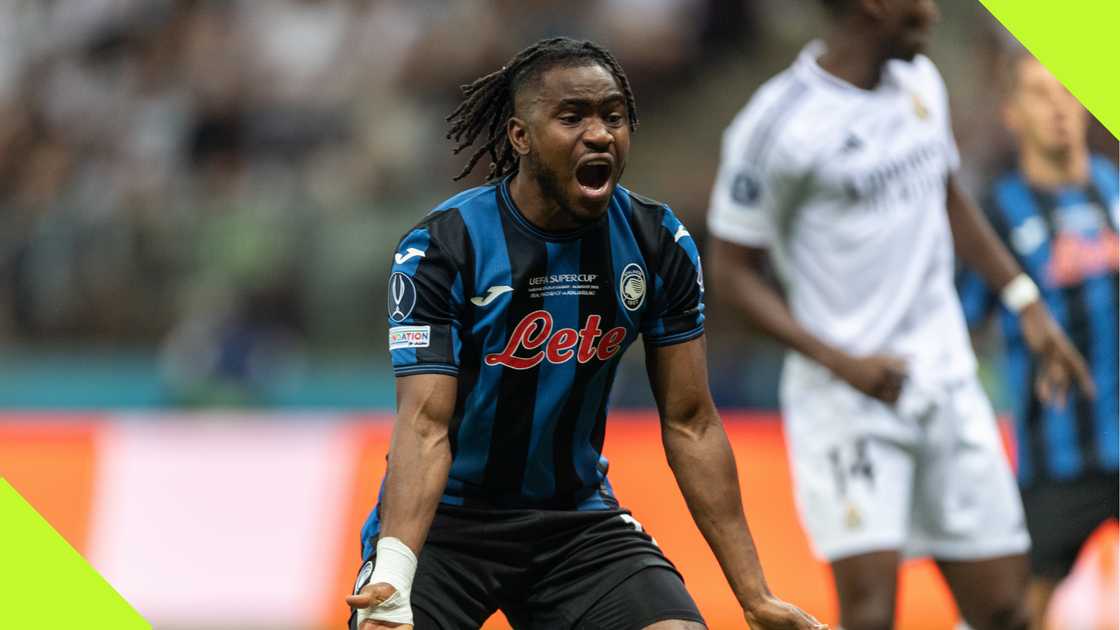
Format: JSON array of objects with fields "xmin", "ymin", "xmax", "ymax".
[{"xmin": 447, "ymin": 37, "xmax": 637, "ymax": 182}]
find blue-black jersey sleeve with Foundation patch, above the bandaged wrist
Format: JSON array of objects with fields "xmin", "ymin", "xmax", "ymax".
[{"xmin": 388, "ymin": 225, "xmax": 464, "ymax": 377}]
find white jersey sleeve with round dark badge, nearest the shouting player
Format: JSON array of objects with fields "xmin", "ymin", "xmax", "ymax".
[{"xmin": 708, "ymin": 107, "xmax": 801, "ymax": 248}]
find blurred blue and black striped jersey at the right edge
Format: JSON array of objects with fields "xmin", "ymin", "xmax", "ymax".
[{"xmin": 959, "ymin": 157, "xmax": 1120, "ymax": 485}]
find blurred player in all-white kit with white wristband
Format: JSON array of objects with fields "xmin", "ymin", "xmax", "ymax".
[{"xmin": 709, "ymin": 0, "xmax": 1092, "ymax": 630}]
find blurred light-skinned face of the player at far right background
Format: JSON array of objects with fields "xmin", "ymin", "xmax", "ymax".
[{"xmin": 1005, "ymin": 57, "xmax": 1088, "ymax": 154}]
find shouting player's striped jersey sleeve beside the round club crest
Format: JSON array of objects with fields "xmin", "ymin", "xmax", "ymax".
[{"xmin": 642, "ymin": 207, "xmax": 704, "ymax": 345}]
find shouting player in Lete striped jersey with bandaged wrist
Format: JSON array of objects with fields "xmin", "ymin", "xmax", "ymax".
[{"xmin": 347, "ymin": 38, "xmax": 821, "ymax": 630}]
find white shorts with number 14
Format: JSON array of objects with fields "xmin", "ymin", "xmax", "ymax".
[{"xmin": 782, "ymin": 360, "xmax": 1030, "ymax": 562}]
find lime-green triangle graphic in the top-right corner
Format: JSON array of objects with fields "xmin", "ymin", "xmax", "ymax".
[{"xmin": 980, "ymin": 0, "xmax": 1120, "ymax": 138}]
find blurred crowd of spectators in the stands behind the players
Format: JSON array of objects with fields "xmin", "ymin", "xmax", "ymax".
[{"xmin": 0, "ymin": 0, "xmax": 1111, "ymax": 403}]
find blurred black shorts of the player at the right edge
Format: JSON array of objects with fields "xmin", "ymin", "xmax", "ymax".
[{"xmin": 1023, "ymin": 473, "xmax": 1120, "ymax": 580}]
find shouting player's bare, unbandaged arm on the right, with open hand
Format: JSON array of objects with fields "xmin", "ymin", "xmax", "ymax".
[{"xmin": 646, "ymin": 336, "xmax": 819, "ymax": 628}]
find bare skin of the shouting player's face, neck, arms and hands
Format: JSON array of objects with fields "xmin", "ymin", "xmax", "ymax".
[{"xmin": 346, "ymin": 65, "xmax": 825, "ymax": 630}]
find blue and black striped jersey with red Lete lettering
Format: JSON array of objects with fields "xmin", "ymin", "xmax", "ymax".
[{"xmin": 363, "ymin": 173, "xmax": 704, "ymax": 551}]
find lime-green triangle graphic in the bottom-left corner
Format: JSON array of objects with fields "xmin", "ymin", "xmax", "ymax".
[{"xmin": 0, "ymin": 478, "xmax": 151, "ymax": 630}]
